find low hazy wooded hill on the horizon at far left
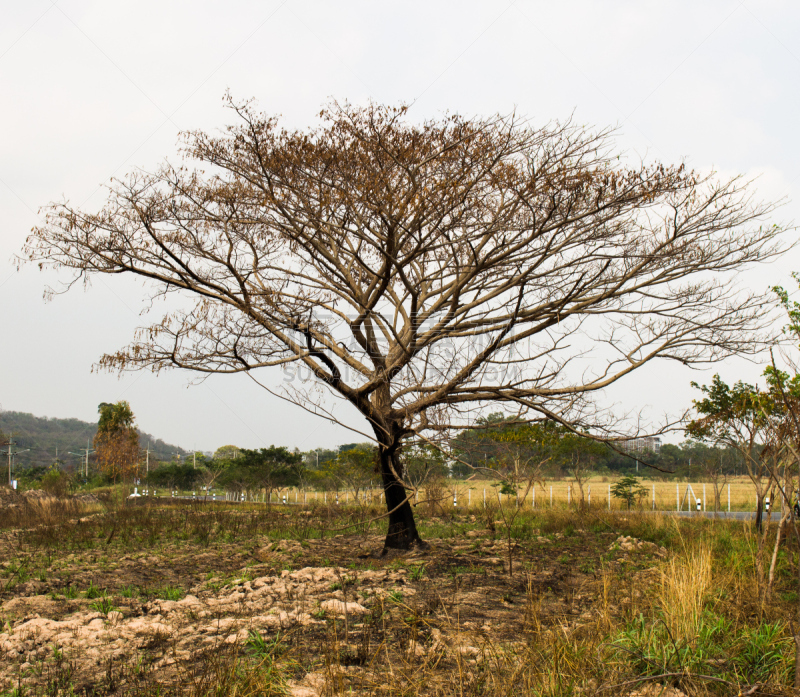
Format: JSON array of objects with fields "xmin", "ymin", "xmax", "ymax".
[{"xmin": 0, "ymin": 411, "xmax": 191, "ymax": 470}]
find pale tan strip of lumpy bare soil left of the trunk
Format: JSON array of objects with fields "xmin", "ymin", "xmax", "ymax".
[{"xmin": 0, "ymin": 567, "xmax": 414, "ymax": 684}]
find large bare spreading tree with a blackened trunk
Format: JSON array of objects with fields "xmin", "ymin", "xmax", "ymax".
[{"xmin": 24, "ymin": 102, "xmax": 780, "ymax": 548}]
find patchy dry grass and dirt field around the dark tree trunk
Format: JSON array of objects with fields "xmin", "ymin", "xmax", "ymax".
[{"xmin": 0, "ymin": 492, "xmax": 798, "ymax": 697}]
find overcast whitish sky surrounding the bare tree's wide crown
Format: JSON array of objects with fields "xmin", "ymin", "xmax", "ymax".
[{"xmin": 0, "ymin": 0, "xmax": 800, "ymax": 450}]
